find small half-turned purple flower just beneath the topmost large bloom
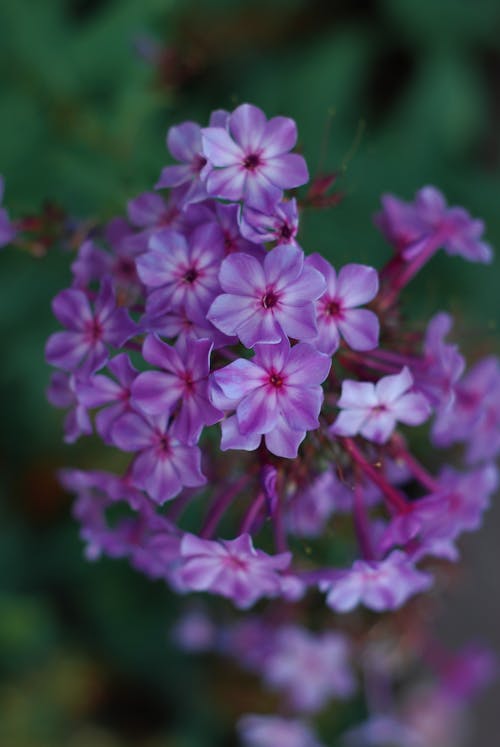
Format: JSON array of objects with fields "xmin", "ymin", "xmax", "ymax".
[{"xmin": 240, "ymin": 198, "xmax": 299, "ymax": 246}]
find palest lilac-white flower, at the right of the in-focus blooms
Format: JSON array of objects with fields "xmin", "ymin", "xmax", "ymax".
[{"xmin": 330, "ymin": 366, "xmax": 430, "ymax": 444}]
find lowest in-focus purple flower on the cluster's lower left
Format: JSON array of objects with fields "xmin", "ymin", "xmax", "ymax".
[{"xmin": 111, "ymin": 412, "xmax": 206, "ymax": 504}]
